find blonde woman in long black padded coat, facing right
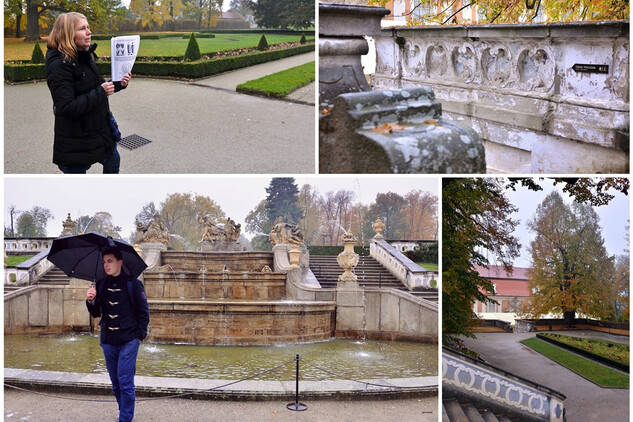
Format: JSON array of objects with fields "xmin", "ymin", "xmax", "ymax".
[{"xmin": 46, "ymin": 12, "xmax": 132, "ymax": 173}]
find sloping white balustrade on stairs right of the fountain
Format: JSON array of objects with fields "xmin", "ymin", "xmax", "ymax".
[{"xmin": 369, "ymin": 239, "xmax": 436, "ymax": 290}]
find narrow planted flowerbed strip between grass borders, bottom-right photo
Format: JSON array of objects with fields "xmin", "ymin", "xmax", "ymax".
[{"xmin": 536, "ymin": 333, "xmax": 629, "ymax": 372}]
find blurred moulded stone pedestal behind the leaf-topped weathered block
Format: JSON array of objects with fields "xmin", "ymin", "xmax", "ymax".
[{"xmin": 319, "ymin": 3, "xmax": 389, "ymax": 106}]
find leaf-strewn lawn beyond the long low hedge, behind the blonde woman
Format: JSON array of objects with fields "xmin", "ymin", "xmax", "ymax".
[{"xmin": 4, "ymin": 32, "xmax": 314, "ymax": 61}]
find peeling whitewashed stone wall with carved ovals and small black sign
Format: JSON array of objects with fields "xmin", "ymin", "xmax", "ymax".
[{"xmin": 372, "ymin": 22, "xmax": 629, "ymax": 173}]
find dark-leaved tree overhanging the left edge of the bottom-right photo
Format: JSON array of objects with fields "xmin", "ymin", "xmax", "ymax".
[{"xmin": 442, "ymin": 178, "xmax": 520, "ymax": 344}]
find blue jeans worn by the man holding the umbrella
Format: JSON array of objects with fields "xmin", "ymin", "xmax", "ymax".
[{"xmin": 101, "ymin": 338, "xmax": 141, "ymax": 422}]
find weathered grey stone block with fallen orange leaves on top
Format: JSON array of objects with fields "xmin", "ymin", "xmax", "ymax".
[{"xmin": 319, "ymin": 88, "xmax": 486, "ymax": 173}]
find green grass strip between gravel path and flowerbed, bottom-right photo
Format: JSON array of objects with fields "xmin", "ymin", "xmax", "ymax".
[{"xmin": 521, "ymin": 338, "xmax": 629, "ymax": 388}]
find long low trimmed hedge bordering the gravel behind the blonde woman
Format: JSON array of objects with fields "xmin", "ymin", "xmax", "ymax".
[{"xmin": 4, "ymin": 44, "xmax": 315, "ymax": 82}]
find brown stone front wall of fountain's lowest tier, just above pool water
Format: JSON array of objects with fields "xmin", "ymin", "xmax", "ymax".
[{"xmin": 100, "ymin": 299, "xmax": 336, "ymax": 346}]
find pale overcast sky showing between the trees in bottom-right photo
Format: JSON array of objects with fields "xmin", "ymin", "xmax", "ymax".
[{"xmin": 492, "ymin": 179, "xmax": 629, "ymax": 267}]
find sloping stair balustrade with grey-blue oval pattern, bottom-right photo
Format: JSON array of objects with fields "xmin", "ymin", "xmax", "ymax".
[{"xmin": 442, "ymin": 347, "xmax": 566, "ymax": 422}]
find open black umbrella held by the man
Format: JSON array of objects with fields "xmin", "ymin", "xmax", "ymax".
[{"xmin": 48, "ymin": 232, "xmax": 147, "ymax": 284}]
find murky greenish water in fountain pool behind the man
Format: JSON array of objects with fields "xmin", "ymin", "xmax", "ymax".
[{"xmin": 4, "ymin": 334, "xmax": 438, "ymax": 380}]
